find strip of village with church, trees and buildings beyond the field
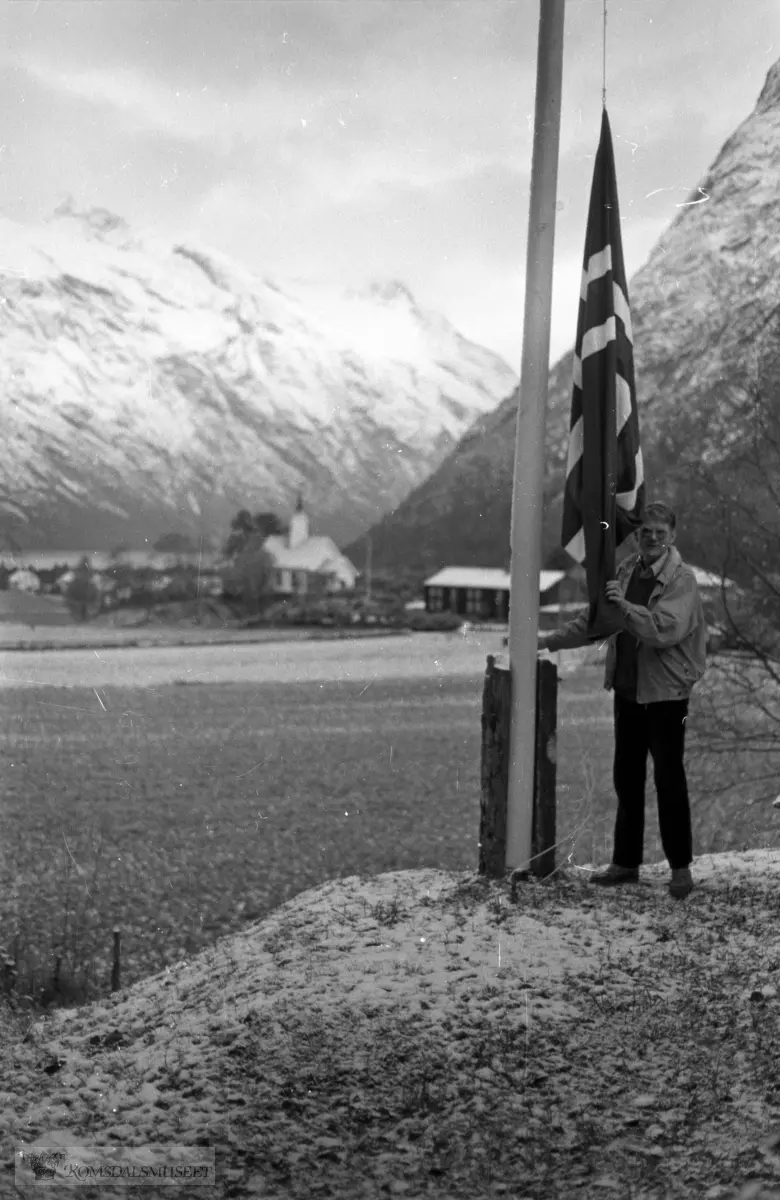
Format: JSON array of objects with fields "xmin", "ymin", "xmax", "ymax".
[{"xmin": 0, "ymin": 494, "xmax": 739, "ymax": 648}]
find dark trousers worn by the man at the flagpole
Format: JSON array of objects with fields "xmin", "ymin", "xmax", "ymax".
[{"xmin": 612, "ymin": 694, "xmax": 694, "ymax": 870}]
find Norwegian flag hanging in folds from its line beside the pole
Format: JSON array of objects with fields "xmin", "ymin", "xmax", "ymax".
[{"xmin": 560, "ymin": 108, "xmax": 644, "ymax": 638}]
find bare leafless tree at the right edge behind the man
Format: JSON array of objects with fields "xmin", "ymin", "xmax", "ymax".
[{"xmin": 676, "ymin": 343, "xmax": 780, "ymax": 808}]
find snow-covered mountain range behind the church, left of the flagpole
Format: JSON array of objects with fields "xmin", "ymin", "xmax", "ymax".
[{"xmin": 0, "ymin": 202, "xmax": 516, "ymax": 548}]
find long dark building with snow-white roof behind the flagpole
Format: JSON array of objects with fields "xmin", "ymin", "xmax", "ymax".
[{"xmin": 422, "ymin": 566, "xmax": 578, "ymax": 622}]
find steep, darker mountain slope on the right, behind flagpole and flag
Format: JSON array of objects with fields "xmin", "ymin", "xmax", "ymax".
[{"xmin": 347, "ymin": 57, "xmax": 780, "ymax": 571}]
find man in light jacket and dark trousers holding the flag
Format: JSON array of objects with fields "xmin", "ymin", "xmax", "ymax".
[{"xmin": 539, "ymin": 503, "xmax": 707, "ymax": 899}]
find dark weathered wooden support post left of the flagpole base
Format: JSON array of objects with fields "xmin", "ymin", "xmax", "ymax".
[{"xmin": 479, "ymin": 654, "xmax": 511, "ymax": 878}]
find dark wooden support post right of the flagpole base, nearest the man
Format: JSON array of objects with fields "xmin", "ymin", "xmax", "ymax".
[{"xmin": 530, "ymin": 659, "xmax": 558, "ymax": 878}]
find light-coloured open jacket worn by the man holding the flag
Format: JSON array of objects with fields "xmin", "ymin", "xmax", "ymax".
[{"xmin": 547, "ymin": 546, "xmax": 707, "ymax": 704}]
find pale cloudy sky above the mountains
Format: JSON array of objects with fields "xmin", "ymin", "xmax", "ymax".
[{"xmin": 0, "ymin": 0, "xmax": 780, "ymax": 370}]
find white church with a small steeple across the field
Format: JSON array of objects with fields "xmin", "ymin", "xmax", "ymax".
[{"xmin": 263, "ymin": 496, "xmax": 358, "ymax": 595}]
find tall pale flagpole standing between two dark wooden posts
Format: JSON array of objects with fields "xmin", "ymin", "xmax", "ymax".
[{"xmin": 505, "ymin": 0, "xmax": 565, "ymax": 870}]
